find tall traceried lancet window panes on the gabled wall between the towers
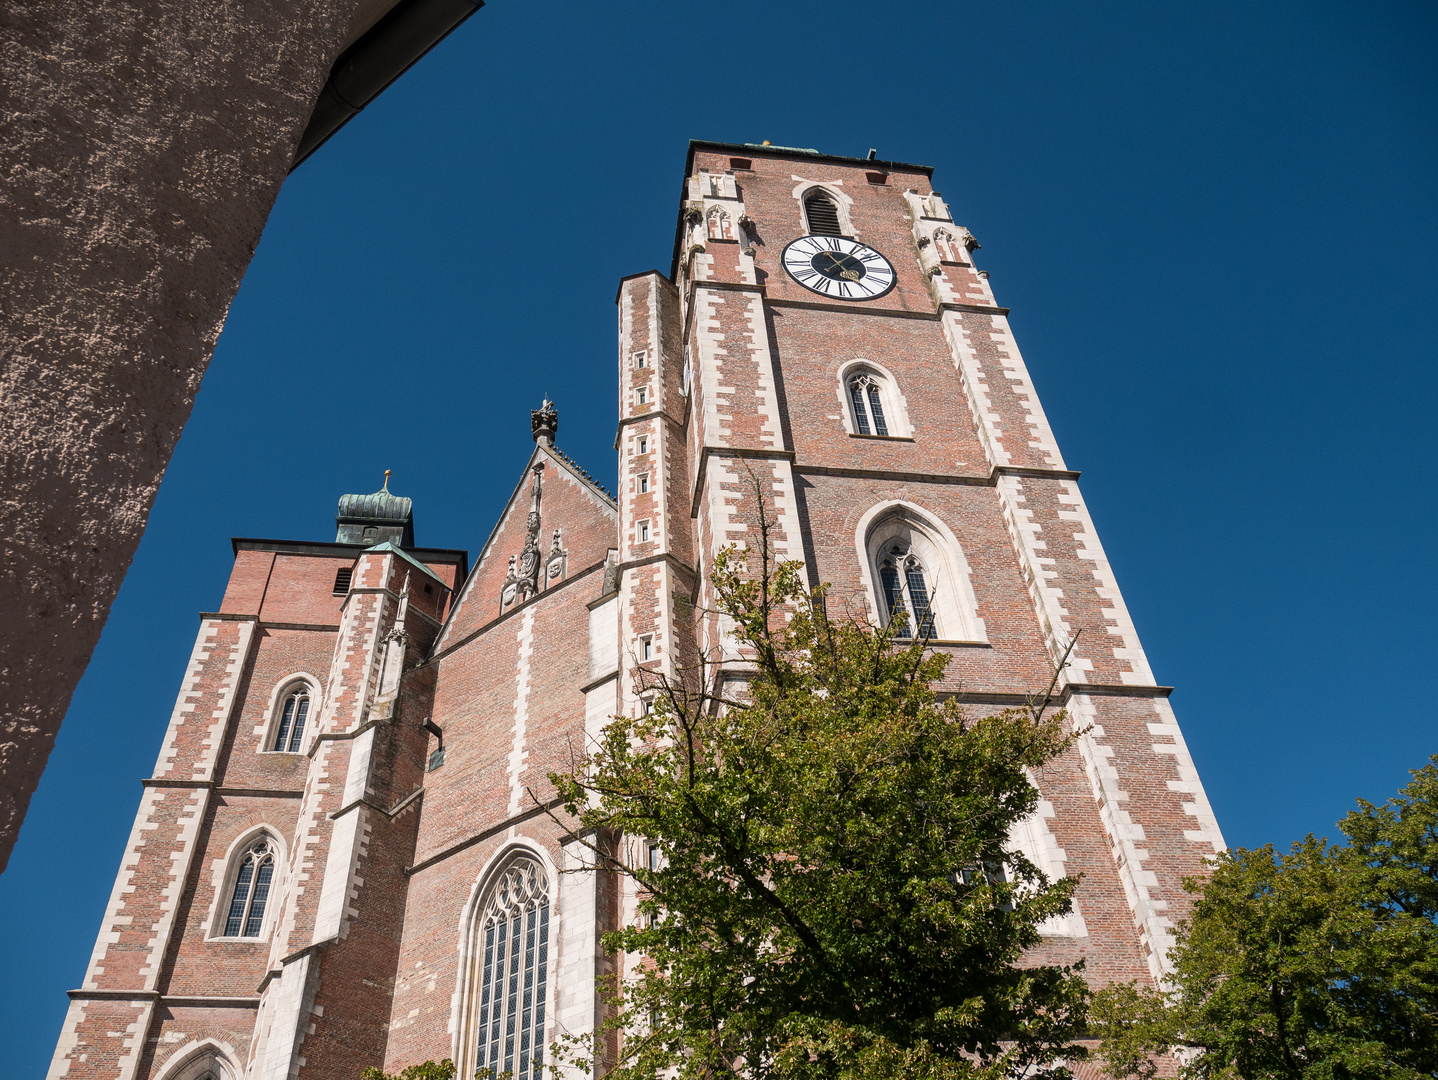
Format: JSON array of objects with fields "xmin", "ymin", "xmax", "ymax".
[{"xmin": 475, "ymin": 856, "xmax": 549, "ymax": 1080}]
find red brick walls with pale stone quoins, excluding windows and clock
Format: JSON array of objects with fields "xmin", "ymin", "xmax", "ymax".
[{"xmin": 62, "ymin": 148, "xmax": 1221, "ymax": 1080}]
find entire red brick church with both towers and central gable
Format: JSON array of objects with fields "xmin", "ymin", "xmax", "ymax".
[{"xmin": 50, "ymin": 142, "xmax": 1222, "ymax": 1080}]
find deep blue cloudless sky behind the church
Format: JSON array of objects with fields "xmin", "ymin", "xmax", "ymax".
[{"xmin": 0, "ymin": 0, "xmax": 1438, "ymax": 1077}]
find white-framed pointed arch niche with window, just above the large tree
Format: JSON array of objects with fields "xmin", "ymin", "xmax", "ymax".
[{"xmin": 854, "ymin": 499, "xmax": 988, "ymax": 643}]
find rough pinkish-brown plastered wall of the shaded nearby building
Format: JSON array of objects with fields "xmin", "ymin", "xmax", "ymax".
[{"xmin": 0, "ymin": 0, "xmax": 365, "ymax": 870}]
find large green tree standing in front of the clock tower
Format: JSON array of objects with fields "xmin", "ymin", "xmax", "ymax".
[{"xmin": 551, "ymin": 497, "xmax": 1087, "ymax": 1080}]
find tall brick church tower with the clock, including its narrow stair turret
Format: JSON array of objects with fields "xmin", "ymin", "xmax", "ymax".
[{"xmin": 618, "ymin": 142, "xmax": 1222, "ymax": 982}]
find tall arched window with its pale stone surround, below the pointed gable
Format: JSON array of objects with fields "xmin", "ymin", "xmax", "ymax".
[{"xmin": 453, "ymin": 843, "xmax": 559, "ymax": 1080}]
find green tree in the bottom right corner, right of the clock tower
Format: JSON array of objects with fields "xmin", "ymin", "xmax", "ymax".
[{"xmin": 1093, "ymin": 756, "xmax": 1438, "ymax": 1080}]
